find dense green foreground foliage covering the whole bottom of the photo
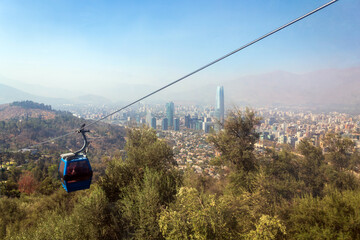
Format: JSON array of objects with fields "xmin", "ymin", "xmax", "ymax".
[{"xmin": 0, "ymin": 111, "xmax": 360, "ymax": 239}]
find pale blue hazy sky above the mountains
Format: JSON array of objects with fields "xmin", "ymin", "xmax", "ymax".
[{"xmin": 0, "ymin": 0, "xmax": 360, "ymax": 99}]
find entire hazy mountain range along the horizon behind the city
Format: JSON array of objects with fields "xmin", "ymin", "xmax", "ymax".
[{"xmin": 0, "ymin": 66, "xmax": 360, "ymax": 112}]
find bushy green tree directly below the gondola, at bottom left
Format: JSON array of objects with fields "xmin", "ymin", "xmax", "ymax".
[{"xmin": 10, "ymin": 186, "xmax": 114, "ymax": 240}]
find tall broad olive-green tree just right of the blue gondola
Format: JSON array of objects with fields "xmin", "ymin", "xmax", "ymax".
[{"xmin": 100, "ymin": 128, "xmax": 181, "ymax": 239}]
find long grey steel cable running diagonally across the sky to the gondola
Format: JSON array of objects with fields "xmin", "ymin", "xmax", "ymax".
[{"xmin": 22, "ymin": 0, "xmax": 338, "ymax": 148}]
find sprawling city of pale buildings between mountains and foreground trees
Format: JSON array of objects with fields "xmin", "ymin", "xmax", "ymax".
[{"xmin": 64, "ymin": 101, "xmax": 360, "ymax": 177}]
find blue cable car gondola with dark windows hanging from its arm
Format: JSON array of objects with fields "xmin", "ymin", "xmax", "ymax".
[{"xmin": 59, "ymin": 124, "xmax": 93, "ymax": 193}]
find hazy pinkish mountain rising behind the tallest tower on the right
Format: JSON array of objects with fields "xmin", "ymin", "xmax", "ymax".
[{"xmin": 165, "ymin": 64, "xmax": 360, "ymax": 113}]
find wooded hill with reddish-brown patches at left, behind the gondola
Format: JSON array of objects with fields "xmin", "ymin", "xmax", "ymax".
[{"xmin": 0, "ymin": 102, "xmax": 125, "ymax": 156}]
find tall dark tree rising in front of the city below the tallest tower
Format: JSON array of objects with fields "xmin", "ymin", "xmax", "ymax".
[{"xmin": 208, "ymin": 109, "xmax": 260, "ymax": 193}]
